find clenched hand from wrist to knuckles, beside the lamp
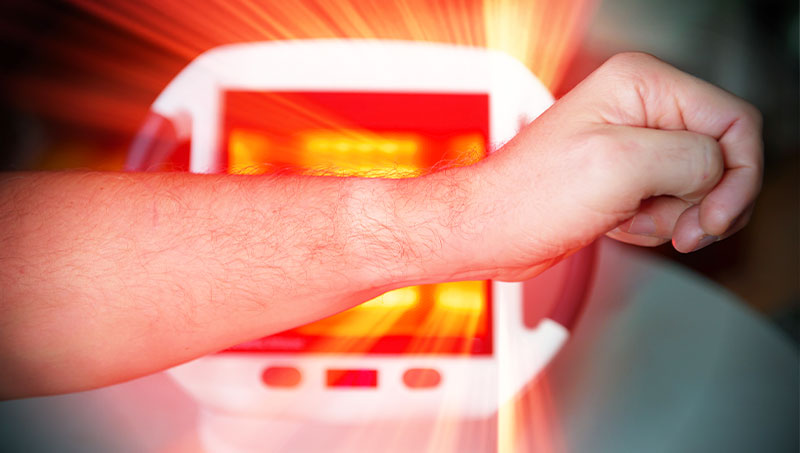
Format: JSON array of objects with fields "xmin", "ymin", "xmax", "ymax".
[{"xmin": 468, "ymin": 53, "xmax": 762, "ymax": 280}]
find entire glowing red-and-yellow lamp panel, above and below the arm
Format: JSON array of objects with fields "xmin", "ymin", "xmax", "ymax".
[{"xmin": 220, "ymin": 91, "xmax": 492, "ymax": 354}]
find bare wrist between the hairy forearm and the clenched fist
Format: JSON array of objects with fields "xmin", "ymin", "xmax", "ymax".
[{"xmin": 345, "ymin": 167, "xmax": 489, "ymax": 290}]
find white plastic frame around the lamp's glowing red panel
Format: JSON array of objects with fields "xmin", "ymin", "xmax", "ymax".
[{"xmin": 147, "ymin": 40, "xmax": 568, "ymax": 422}]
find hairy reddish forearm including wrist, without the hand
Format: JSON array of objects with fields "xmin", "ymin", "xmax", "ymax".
[{"xmin": 0, "ymin": 172, "xmax": 478, "ymax": 396}]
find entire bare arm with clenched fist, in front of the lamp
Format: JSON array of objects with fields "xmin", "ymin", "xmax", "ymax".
[{"xmin": 0, "ymin": 54, "xmax": 762, "ymax": 398}]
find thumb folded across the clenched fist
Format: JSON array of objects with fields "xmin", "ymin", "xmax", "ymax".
[{"xmin": 600, "ymin": 126, "xmax": 723, "ymax": 202}]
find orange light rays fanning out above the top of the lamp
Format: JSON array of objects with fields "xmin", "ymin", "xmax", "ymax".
[{"xmin": 9, "ymin": 0, "xmax": 595, "ymax": 141}]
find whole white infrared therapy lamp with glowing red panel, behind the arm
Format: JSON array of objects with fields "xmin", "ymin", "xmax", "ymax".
[{"xmin": 127, "ymin": 40, "xmax": 594, "ymax": 430}]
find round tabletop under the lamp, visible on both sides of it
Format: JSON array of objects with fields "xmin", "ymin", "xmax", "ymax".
[{"xmin": 0, "ymin": 240, "xmax": 800, "ymax": 453}]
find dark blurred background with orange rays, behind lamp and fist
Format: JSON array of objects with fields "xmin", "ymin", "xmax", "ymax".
[{"xmin": 0, "ymin": 0, "xmax": 800, "ymax": 341}]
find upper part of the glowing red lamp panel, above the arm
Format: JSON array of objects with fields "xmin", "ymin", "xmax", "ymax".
[{"xmin": 223, "ymin": 91, "xmax": 489, "ymax": 178}]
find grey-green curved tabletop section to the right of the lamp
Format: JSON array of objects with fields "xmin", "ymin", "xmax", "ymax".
[{"xmin": 548, "ymin": 238, "xmax": 800, "ymax": 453}]
